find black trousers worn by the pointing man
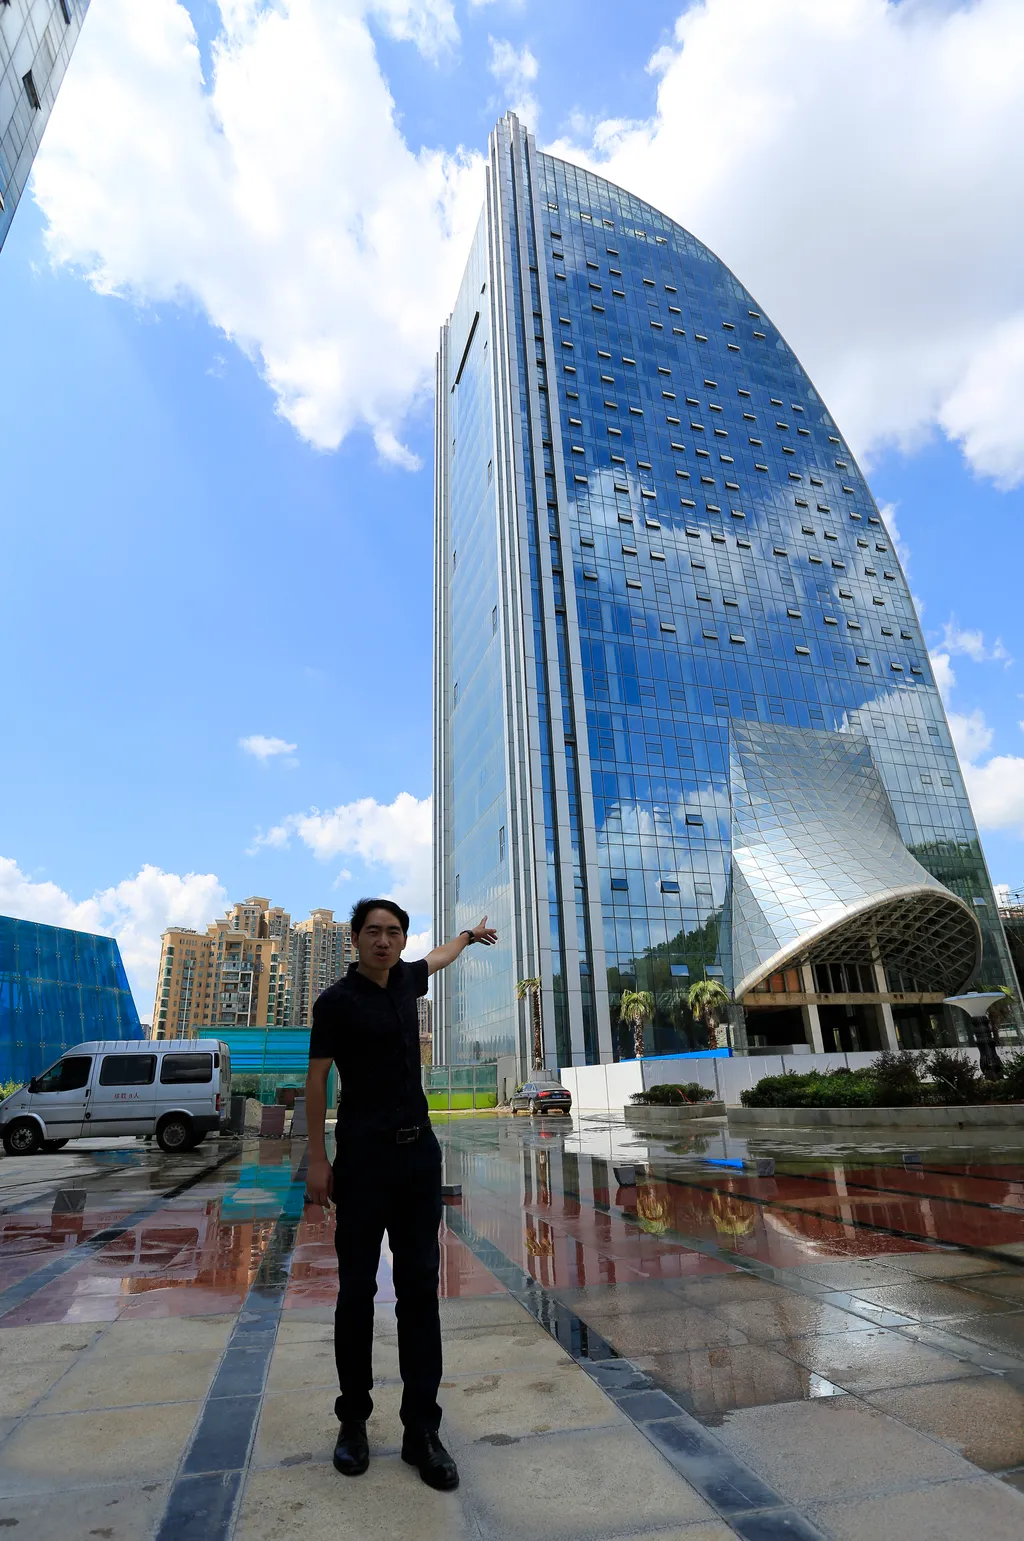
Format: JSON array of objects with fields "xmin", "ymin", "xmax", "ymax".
[{"xmin": 334, "ymin": 1130, "xmax": 442, "ymax": 1430}]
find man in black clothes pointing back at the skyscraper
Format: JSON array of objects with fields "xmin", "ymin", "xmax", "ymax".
[{"xmin": 306, "ymin": 898, "xmax": 497, "ymax": 1490}]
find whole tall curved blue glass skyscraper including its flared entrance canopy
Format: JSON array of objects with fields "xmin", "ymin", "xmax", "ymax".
[{"xmin": 434, "ymin": 114, "xmax": 1015, "ymax": 1066}]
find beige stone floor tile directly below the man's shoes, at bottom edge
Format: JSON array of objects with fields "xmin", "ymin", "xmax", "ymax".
[{"xmin": 234, "ymin": 1456, "xmax": 467, "ymax": 1541}]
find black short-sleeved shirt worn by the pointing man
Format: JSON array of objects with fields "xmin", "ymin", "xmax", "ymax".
[{"xmin": 310, "ymin": 959, "xmax": 430, "ymax": 1134}]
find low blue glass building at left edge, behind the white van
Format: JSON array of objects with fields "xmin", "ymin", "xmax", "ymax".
[{"xmin": 0, "ymin": 915, "xmax": 143, "ymax": 1082}]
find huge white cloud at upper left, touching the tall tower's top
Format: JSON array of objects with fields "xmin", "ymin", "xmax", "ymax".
[{"xmin": 34, "ymin": 0, "xmax": 484, "ymax": 465}]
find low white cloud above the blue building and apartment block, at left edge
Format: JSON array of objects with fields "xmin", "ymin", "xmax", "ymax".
[{"xmin": 0, "ymin": 857, "xmax": 226, "ymax": 1022}]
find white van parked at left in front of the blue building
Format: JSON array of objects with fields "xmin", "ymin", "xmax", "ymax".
[{"xmin": 0, "ymin": 1039, "xmax": 231, "ymax": 1156}]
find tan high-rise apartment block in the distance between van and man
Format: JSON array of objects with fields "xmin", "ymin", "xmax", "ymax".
[{"xmin": 151, "ymin": 895, "xmax": 353, "ymax": 1039}]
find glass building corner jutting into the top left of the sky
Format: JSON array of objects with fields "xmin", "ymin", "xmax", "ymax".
[{"xmin": 0, "ymin": 0, "xmax": 89, "ymax": 247}]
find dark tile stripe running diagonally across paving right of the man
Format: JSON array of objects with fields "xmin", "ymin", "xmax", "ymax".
[{"xmin": 446, "ymin": 1208, "xmax": 824, "ymax": 1541}]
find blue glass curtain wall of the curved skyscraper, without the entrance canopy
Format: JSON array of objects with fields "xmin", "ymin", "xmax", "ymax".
[{"xmin": 437, "ymin": 116, "xmax": 1015, "ymax": 1065}]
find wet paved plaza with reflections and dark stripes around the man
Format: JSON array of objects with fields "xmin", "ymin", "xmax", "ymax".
[{"xmin": 0, "ymin": 1114, "xmax": 1024, "ymax": 1541}]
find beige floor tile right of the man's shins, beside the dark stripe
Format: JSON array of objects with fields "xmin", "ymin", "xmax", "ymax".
[{"xmin": 442, "ymin": 1362, "xmax": 624, "ymax": 1445}]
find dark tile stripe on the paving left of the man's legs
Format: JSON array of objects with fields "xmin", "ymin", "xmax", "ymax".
[{"xmin": 156, "ymin": 1154, "xmax": 308, "ymax": 1541}]
